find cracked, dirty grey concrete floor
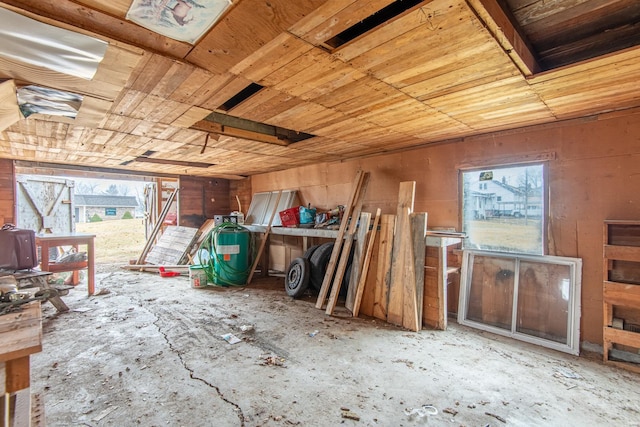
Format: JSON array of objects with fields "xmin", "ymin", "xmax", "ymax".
[{"xmin": 31, "ymin": 269, "xmax": 640, "ymax": 427}]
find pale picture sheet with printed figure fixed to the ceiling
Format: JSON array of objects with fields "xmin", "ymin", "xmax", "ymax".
[{"xmin": 127, "ymin": 0, "xmax": 231, "ymax": 44}]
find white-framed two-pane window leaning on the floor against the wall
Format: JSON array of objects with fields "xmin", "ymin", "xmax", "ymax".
[{"xmin": 458, "ymin": 250, "xmax": 582, "ymax": 355}]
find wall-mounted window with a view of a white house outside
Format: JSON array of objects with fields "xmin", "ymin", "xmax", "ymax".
[{"xmin": 460, "ymin": 163, "xmax": 548, "ymax": 255}]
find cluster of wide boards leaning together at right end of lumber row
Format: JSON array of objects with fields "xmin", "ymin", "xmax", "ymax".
[{"xmin": 353, "ymin": 181, "xmax": 427, "ymax": 331}]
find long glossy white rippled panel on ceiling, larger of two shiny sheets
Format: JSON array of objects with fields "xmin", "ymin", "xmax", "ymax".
[{"xmin": 0, "ymin": 7, "xmax": 108, "ymax": 80}]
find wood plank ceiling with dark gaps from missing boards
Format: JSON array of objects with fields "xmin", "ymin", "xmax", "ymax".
[{"xmin": 0, "ymin": 0, "xmax": 640, "ymax": 178}]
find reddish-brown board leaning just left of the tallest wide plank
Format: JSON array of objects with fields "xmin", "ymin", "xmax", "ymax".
[{"xmin": 373, "ymin": 214, "xmax": 396, "ymax": 321}]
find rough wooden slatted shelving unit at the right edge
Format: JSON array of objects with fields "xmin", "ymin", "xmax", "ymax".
[{"xmin": 602, "ymin": 221, "xmax": 640, "ymax": 373}]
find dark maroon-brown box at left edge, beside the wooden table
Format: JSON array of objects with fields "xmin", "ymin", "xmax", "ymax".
[{"xmin": 0, "ymin": 224, "xmax": 38, "ymax": 270}]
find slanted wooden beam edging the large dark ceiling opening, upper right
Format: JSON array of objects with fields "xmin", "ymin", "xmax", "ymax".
[{"xmin": 466, "ymin": 0, "xmax": 542, "ymax": 77}]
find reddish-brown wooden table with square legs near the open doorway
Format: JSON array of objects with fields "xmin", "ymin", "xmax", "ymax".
[{"xmin": 36, "ymin": 233, "xmax": 96, "ymax": 296}]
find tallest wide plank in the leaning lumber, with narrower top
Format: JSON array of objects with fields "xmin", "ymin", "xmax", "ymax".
[{"xmin": 387, "ymin": 181, "xmax": 418, "ymax": 330}]
